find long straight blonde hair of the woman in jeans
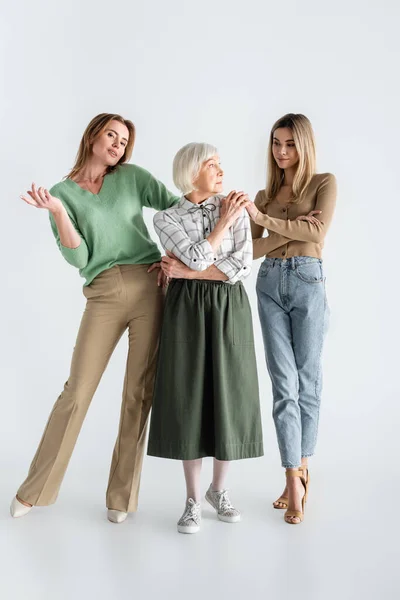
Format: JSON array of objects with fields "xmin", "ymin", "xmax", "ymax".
[{"xmin": 266, "ymin": 113, "xmax": 316, "ymax": 204}]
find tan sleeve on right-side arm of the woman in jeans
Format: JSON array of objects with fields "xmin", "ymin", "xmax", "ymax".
[{"xmin": 255, "ymin": 174, "xmax": 336, "ymax": 244}]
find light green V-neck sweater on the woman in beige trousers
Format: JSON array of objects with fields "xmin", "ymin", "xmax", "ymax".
[{"xmin": 50, "ymin": 164, "xmax": 179, "ymax": 285}]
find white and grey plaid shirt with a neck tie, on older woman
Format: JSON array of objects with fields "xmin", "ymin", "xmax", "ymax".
[{"xmin": 154, "ymin": 195, "xmax": 253, "ymax": 284}]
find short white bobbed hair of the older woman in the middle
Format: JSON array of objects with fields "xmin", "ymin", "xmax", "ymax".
[{"xmin": 172, "ymin": 142, "xmax": 218, "ymax": 194}]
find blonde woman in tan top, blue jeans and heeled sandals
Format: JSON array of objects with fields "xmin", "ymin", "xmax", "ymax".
[{"xmin": 247, "ymin": 114, "xmax": 336, "ymax": 524}]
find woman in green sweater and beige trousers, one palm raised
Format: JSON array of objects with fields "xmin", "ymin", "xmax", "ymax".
[{"xmin": 11, "ymin": 114, "xmax": 178, "ymax": 523}]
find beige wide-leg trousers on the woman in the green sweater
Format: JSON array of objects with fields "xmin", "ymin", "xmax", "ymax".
[{"xmin": 18, "ymin": 265, "xmax": 164, "ymax": 512}]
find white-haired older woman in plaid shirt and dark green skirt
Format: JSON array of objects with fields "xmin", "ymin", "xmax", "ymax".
[{"xmin": 148, "ymin": 143, "xmax": 263, "ymax": 533}]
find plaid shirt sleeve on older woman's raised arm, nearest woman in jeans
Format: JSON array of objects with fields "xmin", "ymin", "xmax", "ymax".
[{"xmin": 214, "ymin": 210, "xmax": 253, "ymax": 284}]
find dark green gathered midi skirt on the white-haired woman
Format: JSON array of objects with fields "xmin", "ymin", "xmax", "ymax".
[{"xmin": 148, "ymin": 279, "xmax": 263, "ymax": 460}]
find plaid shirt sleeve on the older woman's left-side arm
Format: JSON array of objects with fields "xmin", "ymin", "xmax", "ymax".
[{"xmin": 153, "ymin": 211, "xmax": 217, "ymax": 271}]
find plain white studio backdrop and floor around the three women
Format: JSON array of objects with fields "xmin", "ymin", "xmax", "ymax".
[{"xmin": 0, "ymin": 0, "xmax": 400, "ymax": 600}]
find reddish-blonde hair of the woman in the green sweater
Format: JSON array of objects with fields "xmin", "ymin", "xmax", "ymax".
[{"xmin": 67, "ymin": 113, "xmax": 136, "ymax": 179}]
